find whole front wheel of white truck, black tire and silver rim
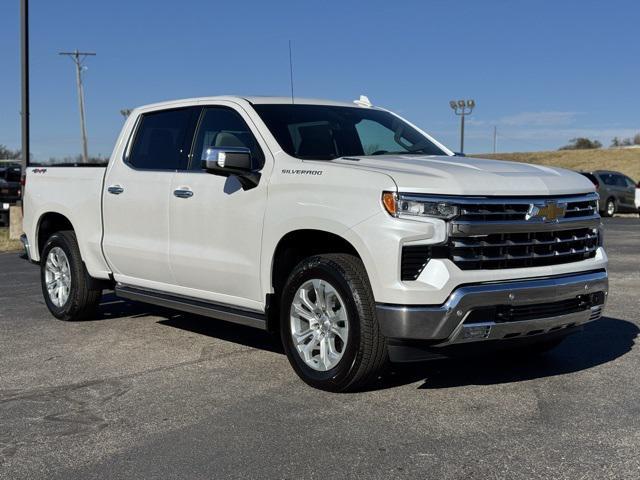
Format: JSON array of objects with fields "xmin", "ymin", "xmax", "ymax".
[{"xmin": 280, "ymin": 254, "xmax": 387, "ymax": 392}]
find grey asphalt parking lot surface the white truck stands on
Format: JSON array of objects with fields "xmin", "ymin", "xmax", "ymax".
[{"xmin": 0, "ymin": 218, "xmax": 640, "ymax": 480}]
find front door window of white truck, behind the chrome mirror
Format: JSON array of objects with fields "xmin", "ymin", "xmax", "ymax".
[{"xmin": 190, "ymin": 107, "xmax": 264, "ymax": 170}]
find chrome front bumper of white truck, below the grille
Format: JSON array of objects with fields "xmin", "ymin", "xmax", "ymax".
[{"xmin": 376, "ymin": 271, "xmax": 608, "ymax": 346}]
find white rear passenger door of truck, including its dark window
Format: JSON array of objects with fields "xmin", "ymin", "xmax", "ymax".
[{"xmin": 103, "ymin": 107, "xmax": 197, "ymax": 290}]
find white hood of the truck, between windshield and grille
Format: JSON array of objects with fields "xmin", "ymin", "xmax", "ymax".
[{"xmin": 333, "ymin": 155, "xmax": 595, "ymax": 196}]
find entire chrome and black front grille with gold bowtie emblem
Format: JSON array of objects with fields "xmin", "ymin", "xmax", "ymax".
[{"xmin": 401, "ymin": 193, "xmax": 600, "ymax": 281}]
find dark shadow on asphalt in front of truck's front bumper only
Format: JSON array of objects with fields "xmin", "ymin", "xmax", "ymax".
[{"xmin": 376, "ymin": 317, "xmax": 640, "ymax": 389}]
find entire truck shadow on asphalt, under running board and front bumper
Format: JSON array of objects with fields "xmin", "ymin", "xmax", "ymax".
[{"xmin": 98, "ymin": 294, "xmax": 640, "ymax": 390}]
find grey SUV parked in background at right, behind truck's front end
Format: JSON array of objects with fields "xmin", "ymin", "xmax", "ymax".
[{"xmin": 580, "ymin": 170, "xmax": 640, "ymax": 217}]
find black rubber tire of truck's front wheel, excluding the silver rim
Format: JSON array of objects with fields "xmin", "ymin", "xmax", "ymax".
[{"xmin": 280, "ymin": 254, "xmax": 388, "ymax": 392}]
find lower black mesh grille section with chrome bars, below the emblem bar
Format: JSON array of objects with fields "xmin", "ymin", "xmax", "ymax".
[{"xmin": 448, "ymin": 228, "xmax": 598, "ymax": 270}]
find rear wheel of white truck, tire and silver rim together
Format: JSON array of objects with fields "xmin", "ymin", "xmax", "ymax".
[{"xmin": 40, "ymin": 230, "xmax": 102, "ymax": 321}]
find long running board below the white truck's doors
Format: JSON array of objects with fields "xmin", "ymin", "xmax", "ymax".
[{"xmin": 115, "ymin": 285, "xmax": 267, "ymax": 330}]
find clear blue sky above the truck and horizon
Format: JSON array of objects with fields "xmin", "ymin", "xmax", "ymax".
[{"xmin": 0, "ymin": 0, "xmax": 640, "ymax": 159}]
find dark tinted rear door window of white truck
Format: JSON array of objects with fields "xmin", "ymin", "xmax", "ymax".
[{"xmin": 127, "ymin": 108, "xmax": 192, "ymax": 170}]
